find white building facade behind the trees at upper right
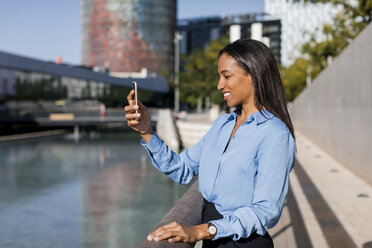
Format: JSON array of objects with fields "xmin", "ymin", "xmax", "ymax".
[{"xmin": 265, "ymin": 0, "xmax": 340, "ymax": 66}]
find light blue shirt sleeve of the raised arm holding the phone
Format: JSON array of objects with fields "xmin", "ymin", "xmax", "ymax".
[{"xmin": 141, "ymin": 133, "xmax": 207, "ymax": 184}]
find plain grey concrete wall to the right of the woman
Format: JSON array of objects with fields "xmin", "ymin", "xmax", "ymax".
[{"xmin": 291, "ymin": 24, "xmax": 372, "ymax": 184}]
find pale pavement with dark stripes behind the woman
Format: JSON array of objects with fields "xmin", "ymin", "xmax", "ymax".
[{"xmin": 177, "ymin": 113, "xmax": 372, "ymax": 248}]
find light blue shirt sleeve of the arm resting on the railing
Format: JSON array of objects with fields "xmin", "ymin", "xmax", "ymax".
[{"xmin": 211, "ymin": 132, "xmax": 296, "ymax": 240}]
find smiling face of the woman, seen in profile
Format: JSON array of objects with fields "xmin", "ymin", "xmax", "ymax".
[{"xmin": 217, "ymin": 53, "xmax": 254, "ymax": 107}]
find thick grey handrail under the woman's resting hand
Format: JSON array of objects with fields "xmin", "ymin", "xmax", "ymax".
[{"xmin": 138, "ymin": 181, "xmax": 203, "ymax": 248}]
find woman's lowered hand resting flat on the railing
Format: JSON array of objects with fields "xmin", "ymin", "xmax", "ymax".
[{"xmin": 147, "ymin": 222, "xmax": 209, "ymax": 243}]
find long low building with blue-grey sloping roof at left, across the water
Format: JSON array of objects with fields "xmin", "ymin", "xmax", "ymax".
[{"xmin": 0, "ymin": 51, "xmax": 169, "ymax": 101}]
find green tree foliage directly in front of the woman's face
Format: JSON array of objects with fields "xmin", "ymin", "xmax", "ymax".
[{"xmin": 180, "ymin": 36, "xmax": 229, "ymax": 107}]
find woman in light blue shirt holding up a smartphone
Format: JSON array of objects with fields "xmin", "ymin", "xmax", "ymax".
[{"xmin": 125, "ymin": 39, "xmax": 296, "ymax": 247}]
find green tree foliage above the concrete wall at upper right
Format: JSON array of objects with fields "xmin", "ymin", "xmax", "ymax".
[{"xmin": 281, "ymin": 0, "xmax": 372, "ymax": 101}]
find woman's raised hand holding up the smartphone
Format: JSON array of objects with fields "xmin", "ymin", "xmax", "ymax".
[{"xmin": 124, "ymin": 90, "xmax": 154, "ymax": 142}]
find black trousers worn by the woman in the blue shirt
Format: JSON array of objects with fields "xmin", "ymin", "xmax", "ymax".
[{"xmin": 202, "ymin": 199, "xmax": 274, "ymax": 248}]
